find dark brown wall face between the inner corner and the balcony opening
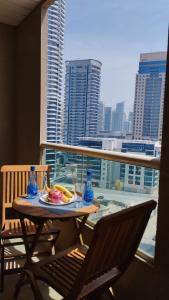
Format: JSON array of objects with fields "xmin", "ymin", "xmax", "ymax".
[{"xmin": 15, "ymin": 8, "xmax": 41, "ymax": 163}]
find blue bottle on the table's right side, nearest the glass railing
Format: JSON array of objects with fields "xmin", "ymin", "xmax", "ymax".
[{"xmin": 82, "ymin": 170, "xmax": 94, "ymax": 205}]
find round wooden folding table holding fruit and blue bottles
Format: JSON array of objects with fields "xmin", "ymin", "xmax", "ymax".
[{"xmin": 12, "ymin": 196, "xmax": 99, "ymax": 261}]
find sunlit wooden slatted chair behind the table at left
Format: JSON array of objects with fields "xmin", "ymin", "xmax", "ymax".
[{"xmin": 0, "ymin": 165, "xmax": 59, "ymax": 291}]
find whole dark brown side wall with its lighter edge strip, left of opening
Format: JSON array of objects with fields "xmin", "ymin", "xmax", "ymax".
[{"xmin": 0, "ymin": 5, "xmax": 47, "ymax": 169}]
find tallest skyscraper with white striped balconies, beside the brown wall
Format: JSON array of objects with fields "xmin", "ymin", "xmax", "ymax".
[{"xmin": 46, "ymin": 0, "xmax": 65, "ymax": 176}]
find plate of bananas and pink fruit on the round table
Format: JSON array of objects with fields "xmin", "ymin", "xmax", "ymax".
[{"xmin": 40, "ymin": 185, "xmax": 79, "ymax": 205}]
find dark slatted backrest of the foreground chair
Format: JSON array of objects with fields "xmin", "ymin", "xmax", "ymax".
[{"xmin": 77, "ymin": 200, "xmax": 156, "ymax": 290}]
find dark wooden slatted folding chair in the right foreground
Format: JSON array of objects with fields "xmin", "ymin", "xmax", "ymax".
[{"xmin": 14, "ymin": 200, "xmax": 156, "ymax": 300}]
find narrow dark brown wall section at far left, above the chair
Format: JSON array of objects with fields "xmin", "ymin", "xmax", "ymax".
[{"xmin": 0, "ymin": 24, "xmax": 16, "ymax": 164}]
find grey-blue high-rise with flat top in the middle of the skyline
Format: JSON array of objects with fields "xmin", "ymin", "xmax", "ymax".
[{"xmin": 64, "ymin": 59, "xmax": 102, "ymax": 145}]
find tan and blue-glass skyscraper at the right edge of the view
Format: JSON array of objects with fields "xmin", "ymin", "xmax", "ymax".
[{"xmin": 133, "ymin": 52, "xmax": 167, "ymax": 140}]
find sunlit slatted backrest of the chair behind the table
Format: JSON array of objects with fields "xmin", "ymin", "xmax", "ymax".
[{"xmin": 1, "ymin": 165, "xmax": 51, "ymax": 226}]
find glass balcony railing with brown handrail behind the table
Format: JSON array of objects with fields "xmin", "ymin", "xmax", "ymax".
[{"xmin": 41, "ymin": 143, "xmax": 160, "ymax": 257}]
